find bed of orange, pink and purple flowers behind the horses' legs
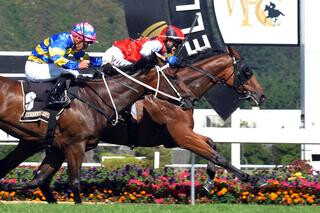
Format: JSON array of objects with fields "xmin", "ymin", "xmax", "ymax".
[{"xmin": 0, "ymin": 160, "xmax": 320, "ymax": 205}]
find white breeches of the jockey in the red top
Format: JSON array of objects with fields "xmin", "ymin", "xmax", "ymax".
[{"xmin": 102, "ymin": 46, "xmax": 132, "ymax": 67}]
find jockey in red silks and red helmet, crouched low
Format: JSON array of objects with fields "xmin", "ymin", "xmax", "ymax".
[{"xmin": 102, "ymin": 25, "xmax": 185, "ymax": 71}]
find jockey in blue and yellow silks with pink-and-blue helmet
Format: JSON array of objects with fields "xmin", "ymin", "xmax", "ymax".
[{"xmin": 25, "ymin": 22, "xmax": 102, "ymax": 107}]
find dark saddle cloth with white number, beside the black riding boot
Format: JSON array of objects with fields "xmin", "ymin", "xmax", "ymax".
[{"xmin": 20, "ymin": 80, "xmax": 63, "ymax": 123}]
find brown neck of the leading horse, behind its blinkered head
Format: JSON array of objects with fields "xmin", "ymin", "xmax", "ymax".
[{"xmin": 177, "ymin": 54, "xmax": 233, "ymax": 98}]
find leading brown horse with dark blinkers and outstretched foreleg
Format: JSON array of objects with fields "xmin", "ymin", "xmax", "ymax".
[{"xmin": 103, "ymin": 48, "xmax": 265, "ymax": 192}]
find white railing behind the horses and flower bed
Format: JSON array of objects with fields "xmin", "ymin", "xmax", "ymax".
[{"xmin": 0, "ymin": 109, "xmax": 320, "ymax": 170}]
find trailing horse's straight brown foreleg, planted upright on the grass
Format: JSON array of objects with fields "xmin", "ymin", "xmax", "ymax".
[{"xmin": 65, "ymin": 143, "xmax": 85, "ymax": 204}]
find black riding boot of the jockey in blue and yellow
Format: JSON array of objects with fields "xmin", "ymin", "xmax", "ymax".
[{"xmin": 47, "ymin": 77, "xmax": 71, "ymax": 108}]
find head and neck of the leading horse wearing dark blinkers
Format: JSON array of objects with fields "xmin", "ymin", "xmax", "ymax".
[{"xmin": 177, "ymin": 48, "xmax": 265, "ymax": 106}]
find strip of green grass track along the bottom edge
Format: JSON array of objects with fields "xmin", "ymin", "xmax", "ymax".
[{"xmin": 0, "ymin": 203, "xmax": 320, "ymax": 213}]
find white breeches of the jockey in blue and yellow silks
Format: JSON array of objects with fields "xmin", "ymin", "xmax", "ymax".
[{"xmin": 25, "ymin": 61, "xmax": 79, "ymax": 81}]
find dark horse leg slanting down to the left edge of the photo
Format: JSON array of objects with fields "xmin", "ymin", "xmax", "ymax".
[{"xmin": 0, "ymin": 141, "xmax": 42, "ymax": 178}]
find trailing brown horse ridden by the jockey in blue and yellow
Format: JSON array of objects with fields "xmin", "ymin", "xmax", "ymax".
[{"xmin": 0, "ymin": 65, "xmax": 185, "ymax": 203}]
